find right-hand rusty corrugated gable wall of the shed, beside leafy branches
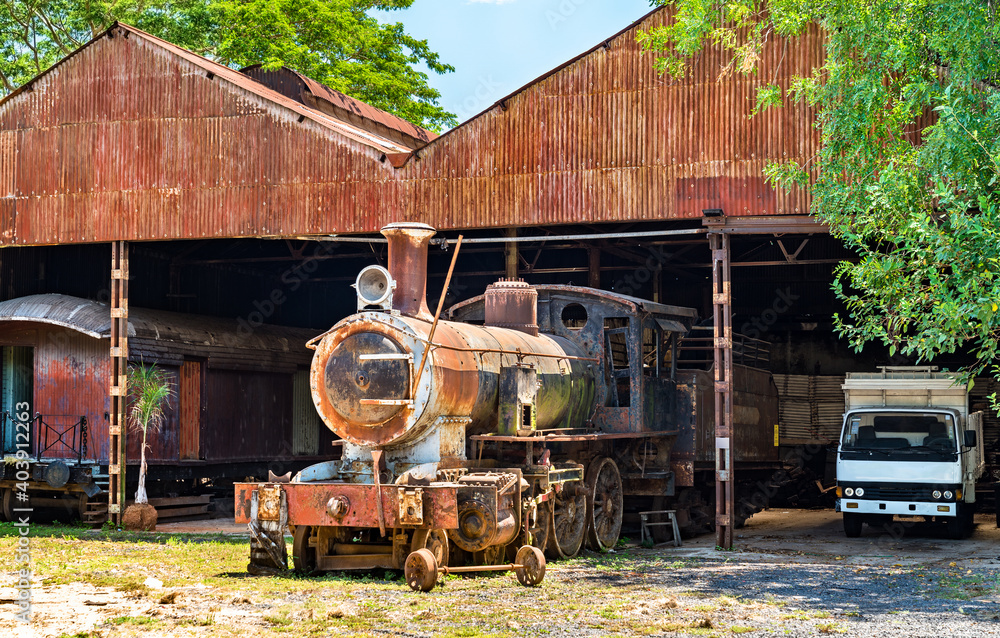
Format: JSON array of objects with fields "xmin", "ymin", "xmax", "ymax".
[{"xmin": 401, "ymin": 11, "xmax": 823, "ymax": 228}]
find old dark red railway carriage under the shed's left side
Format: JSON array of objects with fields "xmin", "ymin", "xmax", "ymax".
[{"xmin": 0, "ymin": 294, "xmax": 333, "ymax": 524}]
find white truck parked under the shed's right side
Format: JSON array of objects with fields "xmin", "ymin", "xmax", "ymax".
[{"xmin": 837, "ymin": 366, "xmax": 985, "ymax": 538}]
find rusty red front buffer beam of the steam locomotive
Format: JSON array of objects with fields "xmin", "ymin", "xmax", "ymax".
[{"xmin": 235, "ymin": 483, "xmax": 459, "ymax": 529}]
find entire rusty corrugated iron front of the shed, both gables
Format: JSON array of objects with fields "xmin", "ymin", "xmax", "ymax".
[{"xmin": 0, "ymin": 10, "xmax": 823, "ymax": 250}]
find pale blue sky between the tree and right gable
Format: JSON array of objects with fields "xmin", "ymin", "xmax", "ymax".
[{"xmin": 376, "ymin": 0, "xmax": 652, "ymax": 122}]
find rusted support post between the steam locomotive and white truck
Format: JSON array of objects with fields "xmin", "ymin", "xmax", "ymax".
[{"xmin": 708, "ymin": 232, "xmax": 736, "ymax": 549}]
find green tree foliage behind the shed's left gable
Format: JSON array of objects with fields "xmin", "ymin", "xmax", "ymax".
[{"xmin": 0, "ymin": 0, "xmax": 456, "ymax": 130}]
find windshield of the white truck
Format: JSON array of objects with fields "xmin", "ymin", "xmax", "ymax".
[{"xmin": 841, "ymin": 412, "xmax": 957, "ymax": 456}]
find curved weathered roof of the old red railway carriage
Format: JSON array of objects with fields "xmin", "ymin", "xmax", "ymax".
[{"xmin": 0, "ymin": 294, "xmax": 316, "ymax": 360}]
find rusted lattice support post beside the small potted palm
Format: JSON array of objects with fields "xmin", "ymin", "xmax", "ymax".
[{"xmin": 108, "ymin": 241, "xmax": 128, "ymax": 525}]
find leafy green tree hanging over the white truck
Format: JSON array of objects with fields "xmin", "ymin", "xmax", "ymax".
[{"xmin": 640, "ymin": 0, "xmax": 1000, "ymax": 384}]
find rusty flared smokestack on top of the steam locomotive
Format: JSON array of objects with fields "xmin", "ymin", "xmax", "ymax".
[{"xmin": 382, "ymin": 222, "xmax": 437, "ymax": 321}]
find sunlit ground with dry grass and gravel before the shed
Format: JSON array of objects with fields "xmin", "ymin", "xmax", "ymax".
[{"xmin": 0, "ymin": 510, "xmax": 1000, "ymax": 638}]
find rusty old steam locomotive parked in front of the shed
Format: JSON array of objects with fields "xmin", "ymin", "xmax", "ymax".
[{"xmin": 236, "ymin": 224, "xmax": 777, "ymax": 588}]
